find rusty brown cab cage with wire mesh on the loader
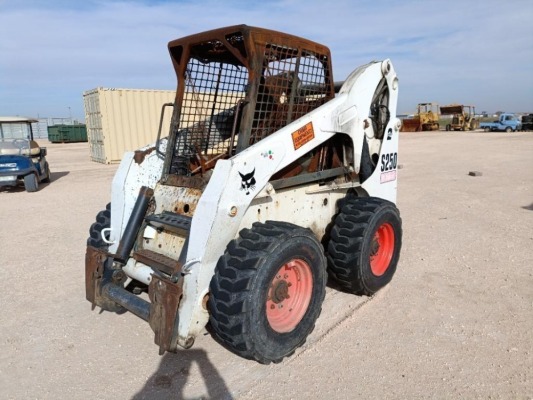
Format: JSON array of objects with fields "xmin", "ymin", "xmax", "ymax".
[{"xmin": 159, "ymin": 26, "xmax": 335, "ymax": 183}]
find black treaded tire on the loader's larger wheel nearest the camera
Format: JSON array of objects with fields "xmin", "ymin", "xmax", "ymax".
[{"xmin": 208, "ymin": 221, "xmax": 327, "ymax": 364}]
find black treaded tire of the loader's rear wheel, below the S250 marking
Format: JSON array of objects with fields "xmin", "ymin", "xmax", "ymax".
[{"xmin": 328, "ymin": 197, "xmax": 402, "ymax": 296}]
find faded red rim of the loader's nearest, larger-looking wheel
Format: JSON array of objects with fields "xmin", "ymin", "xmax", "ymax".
[{"xmin": 266, "ymin": 259, "xmax": 313, "ymax": 333}]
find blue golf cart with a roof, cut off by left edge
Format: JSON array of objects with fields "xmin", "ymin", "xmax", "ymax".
[{"xmin": 0, "ymin": 117, "xmax": 50, "ymax": 192}]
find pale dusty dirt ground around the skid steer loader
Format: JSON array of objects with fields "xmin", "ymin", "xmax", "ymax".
[{"xmin": 0, "ymin": 132, "xmax": 533, "ymax": 400}]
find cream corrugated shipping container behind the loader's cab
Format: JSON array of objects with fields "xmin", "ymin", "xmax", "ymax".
[{"xmin": 83, "ymin": 87, "xmax": 176, "ymax": 164}]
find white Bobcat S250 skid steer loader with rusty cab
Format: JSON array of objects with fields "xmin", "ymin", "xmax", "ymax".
[{"xmin": 86, "ymin": 25, "xmax": 402, "ymax": 364}]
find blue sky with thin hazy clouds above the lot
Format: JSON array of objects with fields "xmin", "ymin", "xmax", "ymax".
[{"xmin": 0, "ymin": 0, "xmax": 533, "ymax": 121}]
